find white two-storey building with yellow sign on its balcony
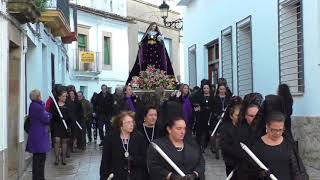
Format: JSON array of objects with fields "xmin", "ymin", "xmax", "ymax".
[{"xmin": 68, "ymin": 0, "xmax": 131, "ymax": 98}]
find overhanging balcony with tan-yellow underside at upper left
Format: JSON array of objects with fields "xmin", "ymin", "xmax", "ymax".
[{"xmin": 40, "ymin": 0, "xmax": 70, "ymax": 37}]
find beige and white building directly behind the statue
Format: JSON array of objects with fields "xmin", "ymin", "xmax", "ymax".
[{"xmin": 127, "ymin": 0, "xmax": 183, "ymax": 80}]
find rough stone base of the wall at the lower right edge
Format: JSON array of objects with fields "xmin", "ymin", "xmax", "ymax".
[{"xmin": 292, "ymin": 117, "xmax": 320, "ymax": 169}]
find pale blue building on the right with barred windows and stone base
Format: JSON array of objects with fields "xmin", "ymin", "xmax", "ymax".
[{"xmin": 179, "ymin": 0, "xmax": 320, "ymax": 169}]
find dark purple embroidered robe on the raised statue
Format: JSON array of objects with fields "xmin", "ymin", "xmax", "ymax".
[{"xmin": 126, "ymin": 23, "xmax": 174, "ymax": 84}]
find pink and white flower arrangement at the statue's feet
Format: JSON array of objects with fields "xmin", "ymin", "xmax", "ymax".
[{"xmin": 131, "ymin": 65, "xmax": 176, "ymax": 90}]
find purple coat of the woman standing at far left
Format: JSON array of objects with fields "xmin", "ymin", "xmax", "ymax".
[{"xmin": 26, "ymin": 101, "xmax": 51, "ymax": 153}]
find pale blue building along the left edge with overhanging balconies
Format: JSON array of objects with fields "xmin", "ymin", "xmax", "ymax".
[{"xmin": 0, "ymin": 0, "xmax": 70, "ymax": 180}]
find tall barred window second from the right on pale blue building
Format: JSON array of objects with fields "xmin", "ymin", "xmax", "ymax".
[{"xmin": 237, "ymin": 16, "xmax": 253, "ymax": 96}]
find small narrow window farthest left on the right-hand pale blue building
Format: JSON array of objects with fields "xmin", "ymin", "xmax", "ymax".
[{"xmin": 188, "ymin": 44, "xmax": 197, "ymax": 88}]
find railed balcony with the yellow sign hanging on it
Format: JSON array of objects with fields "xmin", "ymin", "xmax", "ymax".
[{"xmin": 70, "ymin": 49, "xmax": 102, "ymax": 78}]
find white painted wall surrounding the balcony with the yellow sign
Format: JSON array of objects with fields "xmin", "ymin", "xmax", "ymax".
[{"xmin": 68, "ymin": 10, "xmax": 129, "ymax": 97}]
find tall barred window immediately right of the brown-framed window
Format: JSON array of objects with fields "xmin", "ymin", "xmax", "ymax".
[{"xmin": 221, "ymin": 26, "xmax": 233, "ymax": 91}]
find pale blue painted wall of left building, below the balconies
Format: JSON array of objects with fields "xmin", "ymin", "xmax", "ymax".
[{"xmin": 22, "ymin": 24, "xmax": 68, "ymax": 119}]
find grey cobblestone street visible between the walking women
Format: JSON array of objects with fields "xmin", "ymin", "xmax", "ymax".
[{"xmin": 22, "ymin": 145, "xmax": 320, "ymax": 180}]
